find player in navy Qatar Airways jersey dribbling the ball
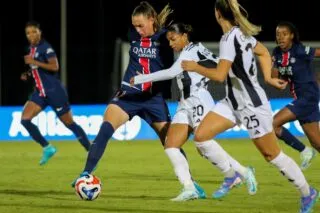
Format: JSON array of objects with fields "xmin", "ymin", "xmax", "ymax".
[{"xmin": 72, "ymin": 1, "xmax": 205, "ymax": 197}]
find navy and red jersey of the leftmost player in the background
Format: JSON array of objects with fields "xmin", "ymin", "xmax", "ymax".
[{"xmin": 29, "ymin": 40, "xmax": 60, "ymax": 97}]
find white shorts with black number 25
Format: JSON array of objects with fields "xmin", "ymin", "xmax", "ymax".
[{"xmin": 211, "ymin": 99, "xmax": 273, "ymax": 139}]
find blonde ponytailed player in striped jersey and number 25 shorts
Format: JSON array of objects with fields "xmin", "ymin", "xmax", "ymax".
[{"xmin": 181, "ymin": 0, "xmax": 319, "ymax": 213}]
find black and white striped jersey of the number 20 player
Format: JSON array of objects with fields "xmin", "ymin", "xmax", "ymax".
[{"xmin": 134, "ymin": 42, "xmax": 218, "ymax": 100}]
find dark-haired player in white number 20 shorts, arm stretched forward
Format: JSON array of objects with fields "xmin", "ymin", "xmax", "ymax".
[{"xmin": 131, "ymin": 23, "xmax": 257, "ymax": 201}]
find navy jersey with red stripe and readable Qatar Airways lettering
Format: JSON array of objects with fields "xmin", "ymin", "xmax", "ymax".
[{"xmin": 121, "ymin": 29, "xmax": 173, "ymax": 95}]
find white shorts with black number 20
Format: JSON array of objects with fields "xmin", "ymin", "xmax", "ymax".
[{"xmin": 171, "ymin": 89, "xmax": 214, "ymax": 129}]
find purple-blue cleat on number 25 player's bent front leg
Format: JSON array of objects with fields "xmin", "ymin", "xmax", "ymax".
[{"xmin": 212, "ymin": 172, "xmax": 242, "ymax": 199}]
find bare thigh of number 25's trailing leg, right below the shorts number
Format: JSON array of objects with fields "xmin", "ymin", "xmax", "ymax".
[{"xmin": 252, "ymin": 131, "xmax": 281, "ymax": 161}]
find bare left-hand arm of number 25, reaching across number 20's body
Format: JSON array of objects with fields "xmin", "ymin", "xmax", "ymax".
[{"xmin": 181, "ymin": 59, "xmax": 232, "ymax": 82}]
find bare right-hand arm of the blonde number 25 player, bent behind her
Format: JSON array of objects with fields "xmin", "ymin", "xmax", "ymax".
[{"xmin": 253, "ymin": 41, "xmax": 287, "ymax": 89}]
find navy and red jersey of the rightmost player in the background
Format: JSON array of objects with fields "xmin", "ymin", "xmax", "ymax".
[{"xmin": 273, "ymin": 44, "xmax": 319, "ymax": 98}]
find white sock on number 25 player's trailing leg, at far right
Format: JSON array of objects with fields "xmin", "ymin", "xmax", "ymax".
[{"xmin": 270, "ymin": 152, "xmax": 310, "ymax": 197}]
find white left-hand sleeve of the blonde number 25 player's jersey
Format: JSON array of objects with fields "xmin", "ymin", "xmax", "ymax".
[{"xmin": 219, "ymin": 35, "xmax": 236, "ymax": 62}]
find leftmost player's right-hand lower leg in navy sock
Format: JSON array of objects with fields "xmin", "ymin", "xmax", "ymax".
[{"xmin": 57, "ymin": 109, "xmax": 91, "ymax": 151}]
